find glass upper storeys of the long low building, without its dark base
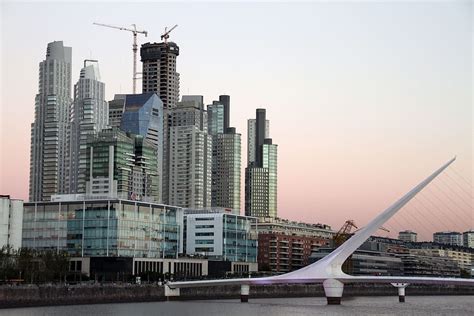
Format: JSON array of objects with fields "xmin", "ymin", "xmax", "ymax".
[{"xmin": 22, "ymin": 199, "xmax": 183, "ymax": 258}]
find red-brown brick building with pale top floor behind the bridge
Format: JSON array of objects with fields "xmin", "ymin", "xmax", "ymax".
[{"xmin": 257, "ymin": 218, "xmax": 334, "ymax": 273}]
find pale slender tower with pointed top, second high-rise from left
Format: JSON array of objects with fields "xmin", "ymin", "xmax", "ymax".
[{"xmin": 67, "ymin": 60, "xmax": 108, "ymax": 194}]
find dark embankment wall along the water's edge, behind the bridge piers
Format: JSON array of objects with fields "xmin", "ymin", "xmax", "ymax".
[{"xmin": 0, "ymin": 284, "xmax": 474, "ymax": 308}]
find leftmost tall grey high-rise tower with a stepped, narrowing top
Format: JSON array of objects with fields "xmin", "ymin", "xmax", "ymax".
[{"xmin": 29, "ymin": 41, "xmax": 72, "ymax": 201}]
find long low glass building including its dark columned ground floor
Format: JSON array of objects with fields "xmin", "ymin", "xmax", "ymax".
[{"xmin": 22, "ymin": 198, "xmax": 208, "ymax": 280}]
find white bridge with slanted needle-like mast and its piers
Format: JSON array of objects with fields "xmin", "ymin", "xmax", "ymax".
[{"xmin": 165, "ymin": 158, "xmax": 474, "ymax": 304}]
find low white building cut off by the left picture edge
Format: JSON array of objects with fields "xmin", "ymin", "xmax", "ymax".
[{"xmin": 0, "ymin": 195, "xmax": 23, "ymax": 249}]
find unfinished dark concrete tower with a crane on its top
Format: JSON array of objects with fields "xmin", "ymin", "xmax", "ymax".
[{"xmin": 140, "ymin": 42, "xmax": 179, "ymax": 110}]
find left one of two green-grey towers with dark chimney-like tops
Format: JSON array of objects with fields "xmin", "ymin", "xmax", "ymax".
[{"xmin": 207, "ymin": 95, "xmax": 241, "ymax": 214}]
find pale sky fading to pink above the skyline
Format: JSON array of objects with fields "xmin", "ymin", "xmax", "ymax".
[{"xmin": 0, "ymin": 1, "xmax": 474, "ymax": 235}]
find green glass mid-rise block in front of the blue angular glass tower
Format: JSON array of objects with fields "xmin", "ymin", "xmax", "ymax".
[{"xmin": 86, "ymin": 129, "xmax": 159, "ymax": 201}]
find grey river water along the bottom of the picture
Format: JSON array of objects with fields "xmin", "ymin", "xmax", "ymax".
[{"xmin": 0, "ymin": 296, "xmax": 474, "ymax": 316}]
